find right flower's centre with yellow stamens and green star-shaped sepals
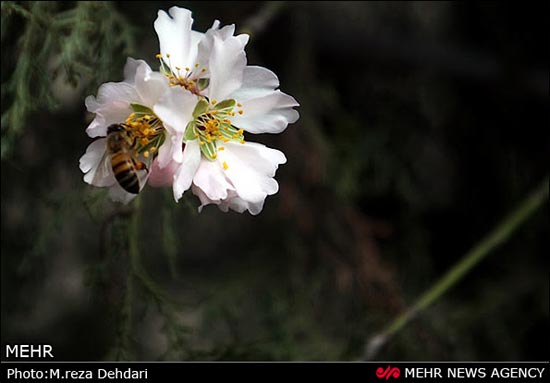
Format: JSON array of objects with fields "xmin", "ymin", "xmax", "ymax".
[{"xmin": 185, "ymin": 99, "xmax": 245, "ymax": 161}]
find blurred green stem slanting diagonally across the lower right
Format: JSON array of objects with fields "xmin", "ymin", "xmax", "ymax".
[{"xmin": 365, "ymin": 177, "xmax": 548, "ymax": 360}]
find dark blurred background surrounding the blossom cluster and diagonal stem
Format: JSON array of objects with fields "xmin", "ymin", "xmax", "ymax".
[{"xmin": 1, "ymin": 1, "xmax": 549, "ymax": 361}]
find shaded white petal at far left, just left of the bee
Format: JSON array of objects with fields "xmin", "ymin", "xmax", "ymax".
[{"xmin": 79, "ymin": 138, "xmax": 116, "ymax": 187}]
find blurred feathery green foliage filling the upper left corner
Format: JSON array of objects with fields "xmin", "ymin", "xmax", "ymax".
[{"xmin": 1, "ymin": 1, "xmax": 134, "ymax": 159}]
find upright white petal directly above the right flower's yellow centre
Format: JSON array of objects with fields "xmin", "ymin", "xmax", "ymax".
[{"xmin": 207, "ymin": 36, "xmax": 246, "ymax": 101}]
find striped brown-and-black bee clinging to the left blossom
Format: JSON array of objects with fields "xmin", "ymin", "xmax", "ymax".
[{"xmin": 107, "ymin": 124, "xmax": 149, "ymax": 194}]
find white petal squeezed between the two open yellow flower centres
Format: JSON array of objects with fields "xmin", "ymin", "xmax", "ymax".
[{"xmin": 153, "ymin": 87, "xmax": 198, "ymax": 134}]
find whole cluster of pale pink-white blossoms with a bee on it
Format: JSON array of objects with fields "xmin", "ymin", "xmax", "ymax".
[{"xmin": 80, "ymin": 7, "xmax": 299, "ymax": 214}]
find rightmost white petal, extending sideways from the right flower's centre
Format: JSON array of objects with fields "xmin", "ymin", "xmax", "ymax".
[{"xmin": 232, "ymin": 90, "xmax": 300, "ymax": 133}]
